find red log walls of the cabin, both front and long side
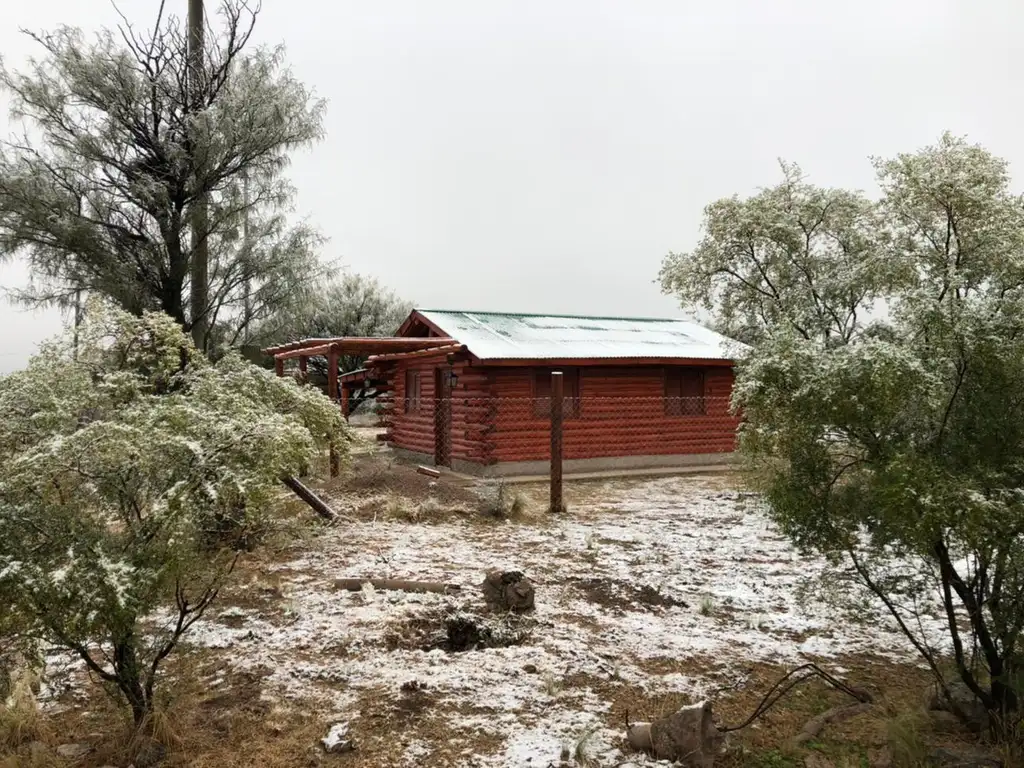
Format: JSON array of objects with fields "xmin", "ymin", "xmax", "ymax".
[{"xmin": 386, "ymin": 355, "xmax": 738, "ymax": 464}]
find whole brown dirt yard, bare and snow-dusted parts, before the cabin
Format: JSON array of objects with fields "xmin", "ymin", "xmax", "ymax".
[{"xmin": 0, "ymin": 436, "xmax": 999, "ymax": 768}]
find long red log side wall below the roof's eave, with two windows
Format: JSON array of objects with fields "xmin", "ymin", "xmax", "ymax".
[{"xmin": 489, "ymin": 367, "xmax": 738, "ymax": 462}]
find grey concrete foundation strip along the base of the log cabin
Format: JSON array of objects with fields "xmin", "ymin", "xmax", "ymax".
[{"xmin": 391, "ymin": 447, "xmax": 735, "ymax": 479}]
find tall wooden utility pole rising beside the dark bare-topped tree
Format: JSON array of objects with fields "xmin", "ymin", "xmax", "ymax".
[{"xmin": 188, "ymin": 0, "xmax": 210, "ymax": 351}]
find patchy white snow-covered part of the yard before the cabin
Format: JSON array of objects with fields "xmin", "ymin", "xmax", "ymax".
[{"xmin": 174, "ymin": 477, "xmax": 942, "ymax": 768}]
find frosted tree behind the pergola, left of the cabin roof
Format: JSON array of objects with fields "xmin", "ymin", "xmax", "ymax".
[{"xmin": 251, "ymin": 273, "xmax": 413, "ymax": 374}]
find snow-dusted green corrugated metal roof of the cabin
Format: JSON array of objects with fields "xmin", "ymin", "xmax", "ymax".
[{"xmin": 418, "ymin": 309, "xmax": 743, "ymax": 359}]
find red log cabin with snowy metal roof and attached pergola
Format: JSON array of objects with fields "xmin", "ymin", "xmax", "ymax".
[{"xmin": 265, "ymin": 309, "xmax": 743, "ymax": 476}]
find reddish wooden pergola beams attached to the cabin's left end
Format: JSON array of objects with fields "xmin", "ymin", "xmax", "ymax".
[{"xmin": 263, "ymin": 336, "xmax": 457, "ymax": 418}]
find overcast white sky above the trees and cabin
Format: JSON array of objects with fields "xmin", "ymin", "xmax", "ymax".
[{"xmin": 0, "ymin": 0, "xmax": 1024, "ymax": 371}]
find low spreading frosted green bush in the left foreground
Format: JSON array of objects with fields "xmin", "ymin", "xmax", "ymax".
[{"xmin": 0, "ymin": 307, "xmax": 344, "ymax": 723}]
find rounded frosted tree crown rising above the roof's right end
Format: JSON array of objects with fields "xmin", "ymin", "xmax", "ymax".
[{"xmin": 659, "ymin": 163, "xmax": 892, "ymax": 343}]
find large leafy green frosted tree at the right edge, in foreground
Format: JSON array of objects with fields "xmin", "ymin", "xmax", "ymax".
[{"xmin": 666, "ymin": 134, "xmax": 1024, "ymax": 733}]
